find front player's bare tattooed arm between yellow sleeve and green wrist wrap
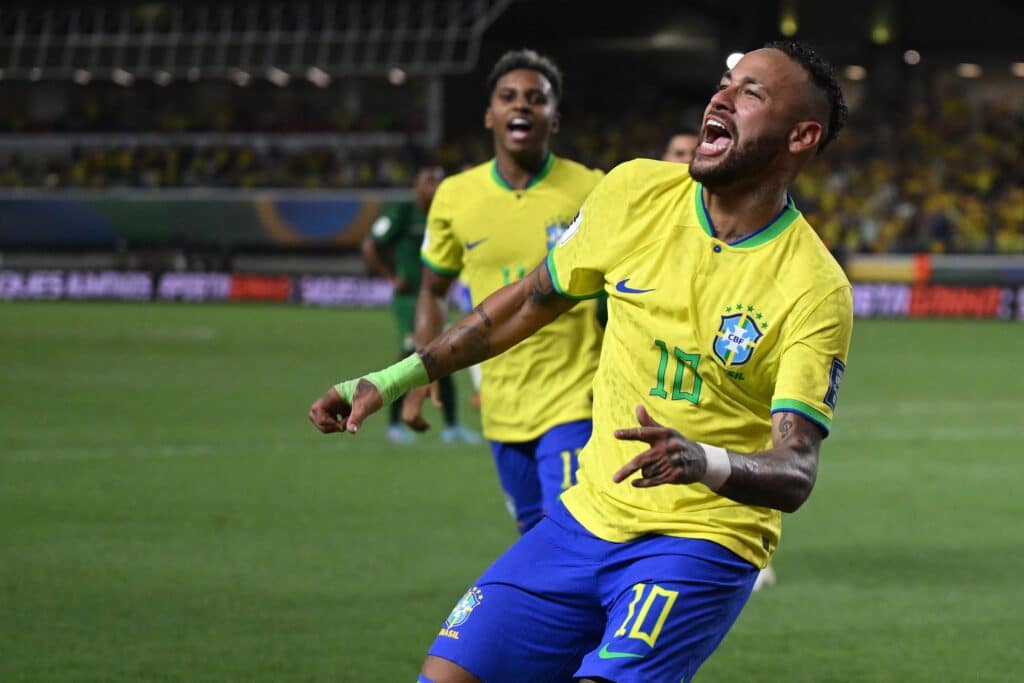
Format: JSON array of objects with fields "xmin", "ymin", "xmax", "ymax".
[{"xmin": 418, "ymin": 263, "xmax": 578, "ymax": 380}]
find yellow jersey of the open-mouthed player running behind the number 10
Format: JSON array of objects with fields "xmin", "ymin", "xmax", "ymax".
[{"xmin": 422, "ymin": 155, "xmax": 602, "ymax": 442}]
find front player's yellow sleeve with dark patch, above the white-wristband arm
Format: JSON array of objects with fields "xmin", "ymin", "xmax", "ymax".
[{"xmin": 771, "ymin": 286, "xmax": 853, "ymax": 435}]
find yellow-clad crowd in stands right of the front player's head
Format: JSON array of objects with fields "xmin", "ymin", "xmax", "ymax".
[{"xmin": 795, "ymin": 80, "xmax": 1024, "ymax": 254}]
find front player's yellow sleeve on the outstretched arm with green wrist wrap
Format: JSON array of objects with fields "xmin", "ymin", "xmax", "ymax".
[{"xmin": 547, "ymin": 165, "xmax": 629, "ymax": 299}]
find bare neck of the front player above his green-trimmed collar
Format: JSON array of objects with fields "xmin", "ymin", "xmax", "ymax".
[{"xmin": 703, "ymin": 176, "xmax": 786, "ymax": 244}]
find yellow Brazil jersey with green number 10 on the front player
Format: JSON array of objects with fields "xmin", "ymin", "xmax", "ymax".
[{"xmin": 548, "ymin": 160, "xmax": 853, "ymax": 566}]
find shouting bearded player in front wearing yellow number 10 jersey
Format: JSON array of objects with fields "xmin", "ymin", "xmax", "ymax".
[{"xmin": 309, "ymin": 42, "xmax": 853, "ymax": 683}]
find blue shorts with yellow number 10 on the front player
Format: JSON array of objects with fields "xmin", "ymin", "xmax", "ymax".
[{"xmin": 430, "ymin": 504, "xmax": 758, "ymax": 683}]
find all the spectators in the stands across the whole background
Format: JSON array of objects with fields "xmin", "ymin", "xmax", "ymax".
[{"xmin": 0, "ymin": 78, "xmax": 1024, "ymax": 253}]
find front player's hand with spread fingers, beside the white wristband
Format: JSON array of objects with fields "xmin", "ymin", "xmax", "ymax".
[{"xmin": 611, "ymin": 405, "xmax": 708, "ymax": 488}]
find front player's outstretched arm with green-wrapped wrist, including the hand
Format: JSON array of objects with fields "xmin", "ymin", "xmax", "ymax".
[{"xmin": 309, "ymin": 263, "xmax": 577, "ymax": 433}]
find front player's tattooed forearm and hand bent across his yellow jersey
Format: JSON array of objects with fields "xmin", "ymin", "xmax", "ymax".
[{"xmin": 613, "ymin": 405, "xmax": 824, "ymax": 512}]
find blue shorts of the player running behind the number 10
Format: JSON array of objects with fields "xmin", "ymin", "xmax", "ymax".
[{"xmin": 490, "ymin": 420, "xmax": 593, "ymax": 533}]
